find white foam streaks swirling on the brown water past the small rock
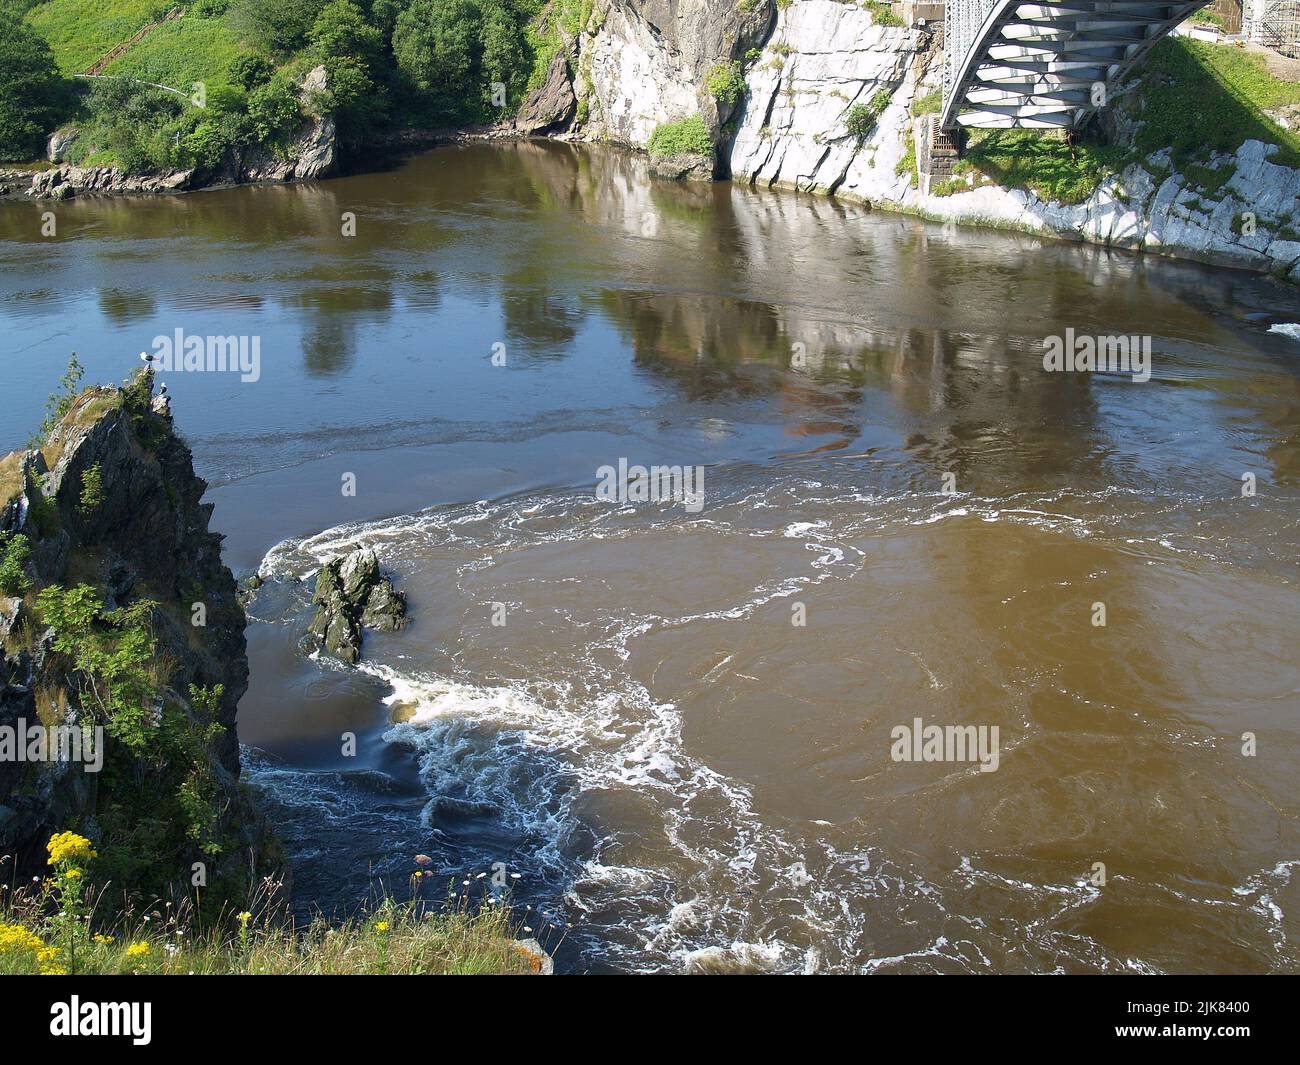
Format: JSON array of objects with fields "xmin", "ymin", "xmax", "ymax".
[{"xmin": 248, "ymin": 481, "xmax": 1281, "ymax": 971}]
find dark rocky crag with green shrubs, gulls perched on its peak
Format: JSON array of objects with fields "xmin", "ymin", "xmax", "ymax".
[{"xmin": 0, "ymin": 371, "xmax": 276, "ymax": 904}]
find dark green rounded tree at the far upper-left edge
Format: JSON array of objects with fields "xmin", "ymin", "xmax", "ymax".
[{"xmin": 0, "ymin": 10, "xmax": 73, "ymax": 159}]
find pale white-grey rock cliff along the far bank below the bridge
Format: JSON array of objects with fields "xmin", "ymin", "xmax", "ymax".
[{"xmin": 525, "ymin": 0, "xmax": 1300, "ymax": 282}]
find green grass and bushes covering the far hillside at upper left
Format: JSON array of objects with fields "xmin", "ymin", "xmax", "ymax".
[{"xmin": 13, "ymin": 0, "xmax": 553, "ymax": 173}]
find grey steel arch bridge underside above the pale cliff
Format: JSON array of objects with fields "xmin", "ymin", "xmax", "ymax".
[{"xmin": 939, "ymin": 0, "xmax": 1210, "ymax": 130}]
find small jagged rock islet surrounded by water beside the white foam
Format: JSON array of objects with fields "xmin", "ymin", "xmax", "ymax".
[{"xmin": 308, "ymin": 547, "xmax": 407, "ymax": 662}]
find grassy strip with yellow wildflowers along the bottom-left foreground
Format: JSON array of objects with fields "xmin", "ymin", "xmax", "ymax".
[{"xmin": 0, "ymin": 832, "xmax": 542, "ymax": 977}]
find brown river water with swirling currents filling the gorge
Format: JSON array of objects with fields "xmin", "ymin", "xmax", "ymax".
[{"xmin": 0, "ymin": 143, "xmax": 1300, "ymax": 973}]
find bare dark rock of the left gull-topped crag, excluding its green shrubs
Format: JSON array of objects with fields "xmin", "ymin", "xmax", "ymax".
[{"xmin": 0, "ymin": 371, "xmax": 277, "ymax": 897}]
